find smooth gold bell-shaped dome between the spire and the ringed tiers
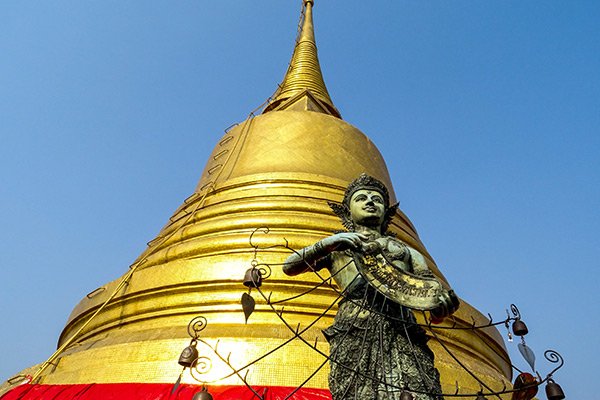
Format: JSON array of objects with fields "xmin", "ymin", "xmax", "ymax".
[{"xmin": 197, "ymin": 111, "xmax": 391, "ymax": 197}]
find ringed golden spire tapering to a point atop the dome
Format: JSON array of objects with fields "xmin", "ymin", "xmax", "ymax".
[{"xmin": 264, "ymin": 0, "xmax": 340, "ymax": 118}]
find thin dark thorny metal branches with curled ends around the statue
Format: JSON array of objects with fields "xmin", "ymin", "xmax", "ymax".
[{"xmin": 179, "ymin": 227, "xmax": 564, "ymax": 400}]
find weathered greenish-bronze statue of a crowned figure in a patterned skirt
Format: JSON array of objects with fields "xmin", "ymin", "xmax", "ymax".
[{"xmin": 283, "ymin": 174, "xmax": 458, "ymax": 400}]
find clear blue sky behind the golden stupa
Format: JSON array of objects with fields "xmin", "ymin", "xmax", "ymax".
[{"xmin": 0, "ymin": 0, "xmax": 600, "ymax": 398}]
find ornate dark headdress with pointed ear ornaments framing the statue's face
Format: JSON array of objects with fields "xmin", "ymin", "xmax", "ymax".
[{"xmin": 329, "ymin": 173, "xmax": 398, "ymax": 234}]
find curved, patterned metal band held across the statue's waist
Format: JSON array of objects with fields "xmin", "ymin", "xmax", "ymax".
[{"xmin": 353, "ymin": 252, "xmax": 443, "ymax": 311}]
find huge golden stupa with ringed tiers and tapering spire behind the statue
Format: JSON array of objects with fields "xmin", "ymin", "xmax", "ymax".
[{"xmin": 0, "ymin": 0, "xmax": 512, "ymax": 399}]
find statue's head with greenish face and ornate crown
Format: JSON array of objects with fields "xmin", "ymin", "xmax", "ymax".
[{"xmin": 329, "ymin": 173, "xmax": 398, "ymax": 233}]
